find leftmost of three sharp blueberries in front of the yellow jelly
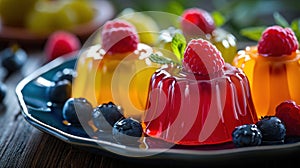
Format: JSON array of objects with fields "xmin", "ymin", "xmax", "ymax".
[{"xmin": 62, "ymin": 98, "xmax": 93, "ymax": 125}]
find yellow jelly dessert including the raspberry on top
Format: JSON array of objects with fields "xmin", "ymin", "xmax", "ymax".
[{"xmin": 72, "ymin": 21, "xmax": 159, "ymax": 119}]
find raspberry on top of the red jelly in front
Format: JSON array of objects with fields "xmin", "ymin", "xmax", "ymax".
[{"xmin": 182, "ymin": 39, "xmax": 225, "ymax": 75}]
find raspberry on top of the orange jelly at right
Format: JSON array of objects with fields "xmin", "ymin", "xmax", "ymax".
[{"xmin": 258, "ymin": 26, "xmax": 299, "ymax": 56}]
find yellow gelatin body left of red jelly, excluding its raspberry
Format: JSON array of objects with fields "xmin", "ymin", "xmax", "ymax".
[{"xmin": 72, "ymin": 43, "xmax": 160, "ymax": 120}]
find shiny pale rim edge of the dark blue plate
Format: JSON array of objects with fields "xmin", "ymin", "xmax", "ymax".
[{"xmin": 15, "ymin": 53, "xmax": 300, "ymax": 162}]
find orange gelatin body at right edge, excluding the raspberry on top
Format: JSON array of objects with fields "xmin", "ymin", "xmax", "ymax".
[{"xmin": 233, "ymin": 46, "xmax": 300, "ymax": 117}]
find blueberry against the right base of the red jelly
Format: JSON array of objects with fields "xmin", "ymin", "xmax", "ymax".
[{"xmin": 232, "ymin": 124, "xmax": 262, "ymax": 147}]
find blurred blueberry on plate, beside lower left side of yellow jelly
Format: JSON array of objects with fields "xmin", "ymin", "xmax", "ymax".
[{"xmin": 46, "ymin": 80, "xmax": 72, "ymax": 104}]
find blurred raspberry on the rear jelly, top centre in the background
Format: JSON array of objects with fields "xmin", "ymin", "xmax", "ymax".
[{"xmin": 181, "ymin": 8, "xmax": 216, "ymax": 34}]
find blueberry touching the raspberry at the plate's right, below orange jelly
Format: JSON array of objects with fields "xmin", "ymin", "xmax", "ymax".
[{"xmin": 256, "ymin": 116, "xmax": 286, "ymax": 144}]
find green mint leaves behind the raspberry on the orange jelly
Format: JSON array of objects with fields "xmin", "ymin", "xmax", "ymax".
[{"xmin": 240, "ymin": 12, "xmax": 300, "ymax": 43}]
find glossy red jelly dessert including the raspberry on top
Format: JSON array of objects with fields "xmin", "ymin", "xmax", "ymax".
[{"xmin": 142, "ymin": 39, "xmax": 258, "ymax": 145}]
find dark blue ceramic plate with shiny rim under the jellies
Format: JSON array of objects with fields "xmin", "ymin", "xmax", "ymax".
[{"xmin": 16, "ymin": 55, "xmax": 300, "ymax": 165}]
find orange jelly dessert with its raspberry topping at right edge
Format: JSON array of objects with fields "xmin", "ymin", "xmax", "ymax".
[{"xmin": 233, "ymin": 26, "xmax": 300, "ymax": 117}]
